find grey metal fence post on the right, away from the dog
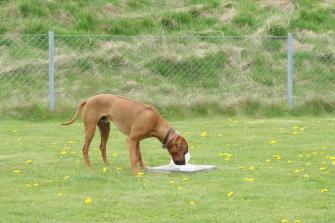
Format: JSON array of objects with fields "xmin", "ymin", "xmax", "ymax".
[{"xmin": 287, "ymin": 33, "xmax": 293, "ymax": 109}]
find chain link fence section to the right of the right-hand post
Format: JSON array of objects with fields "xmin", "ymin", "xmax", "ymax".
[{"xmin": 293, "ymin": 36, "xmax": 335, "ymax": 110}]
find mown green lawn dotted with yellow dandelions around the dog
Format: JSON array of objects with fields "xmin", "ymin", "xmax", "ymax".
[{"xmin": 0, "ymin": 117, "xmax": 335, "ymax": 222}]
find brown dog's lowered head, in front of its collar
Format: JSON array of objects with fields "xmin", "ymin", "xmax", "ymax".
[{"xmin": 167, "ymin": 135, "xmax": 188, "ymax": 165}]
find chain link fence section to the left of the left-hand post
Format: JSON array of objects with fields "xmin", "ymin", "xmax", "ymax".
[{"xmin": 0, "ymin": 35, "xmax": 48, "ymax": 115}]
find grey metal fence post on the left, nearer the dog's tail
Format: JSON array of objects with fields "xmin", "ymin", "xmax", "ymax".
[{"xmin": 49, "ymin": 31, "xmax": 55, "ymax": 112}]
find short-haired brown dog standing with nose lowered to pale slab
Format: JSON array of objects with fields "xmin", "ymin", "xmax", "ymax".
[{"xmin": 63, "ymin": 94, "xmax": 188, "ymax": 174}]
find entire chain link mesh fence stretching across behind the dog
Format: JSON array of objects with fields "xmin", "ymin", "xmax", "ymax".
[{"xmin": 0, "ymin": 35, "xmax": 335, "ymax": 116}]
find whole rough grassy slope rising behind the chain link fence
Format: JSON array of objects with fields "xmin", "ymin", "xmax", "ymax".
[{"xmin": 0, "ymin": 0, "xmax": 335, "ymax": 117}]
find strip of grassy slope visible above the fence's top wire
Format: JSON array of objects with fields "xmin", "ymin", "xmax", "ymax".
[{"xmin": 0, "ymin": 0, "xmax": 335, "ymax": 35}]
